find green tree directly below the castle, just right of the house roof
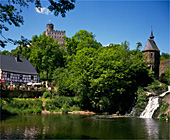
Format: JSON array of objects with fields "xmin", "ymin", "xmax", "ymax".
[{"xmin": 29, "ymin": 34, "xmax": 65, "ymax": 79}]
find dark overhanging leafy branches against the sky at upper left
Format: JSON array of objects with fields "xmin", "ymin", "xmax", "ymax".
[{"xmin": 0, "ymin": 0, "xmax": 75, "ymax": 47}]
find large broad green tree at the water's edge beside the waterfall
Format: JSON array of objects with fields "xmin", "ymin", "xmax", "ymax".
[{"xmin": 53, "ymin": 42, "xmax": 152, "ymax": 114}]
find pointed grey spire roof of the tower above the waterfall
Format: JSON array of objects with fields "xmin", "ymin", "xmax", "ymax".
[{"xmin": 142, "ymin": 28, "xmax": 160, "ymax": 52}]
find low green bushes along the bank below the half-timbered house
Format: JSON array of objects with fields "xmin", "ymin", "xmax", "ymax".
[{"xmin": 0, "ymin": 96, "xmax": 80, "ymax": 119}]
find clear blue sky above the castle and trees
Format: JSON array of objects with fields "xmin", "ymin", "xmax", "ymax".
[{"xmin": 0, "ymin": 0, "xmax": 170, "ymax": 54}]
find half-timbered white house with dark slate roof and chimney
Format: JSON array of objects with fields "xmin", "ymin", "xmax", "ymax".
[{"xmin": 0, "ymin": 54, "xmax": 39, "ymax": 84}]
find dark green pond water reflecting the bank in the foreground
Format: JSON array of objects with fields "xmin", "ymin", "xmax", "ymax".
[{"xmin": 0, "ymin": 114, "xmax": 170, "ymax": 139}]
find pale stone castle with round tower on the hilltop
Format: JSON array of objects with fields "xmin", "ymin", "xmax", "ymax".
[{"xmin": 44, "ymin": 24, "xmax": 66, "ymax": 44}]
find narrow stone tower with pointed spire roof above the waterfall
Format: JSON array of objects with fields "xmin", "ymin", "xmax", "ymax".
[{"xmin": 142, "ymin": 29, "xmax": 160, "ymax": 79}]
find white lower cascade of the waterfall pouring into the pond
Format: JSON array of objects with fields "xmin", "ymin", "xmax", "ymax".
[{"xmin": 140, "ymin": 96, "xmax": 159, "ymax": 118}]
